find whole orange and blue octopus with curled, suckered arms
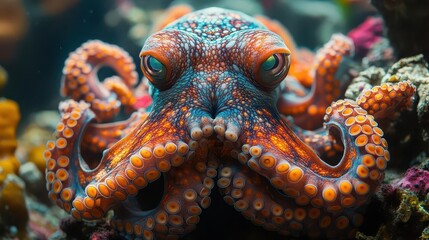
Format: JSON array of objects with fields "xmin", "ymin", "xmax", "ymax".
[{"xmin": 44, "ymin": 8, "xmax": 415, "ymax": 239}]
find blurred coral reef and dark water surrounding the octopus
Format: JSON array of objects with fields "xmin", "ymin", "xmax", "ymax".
[{"xmin": 0, "ymin": 0, "xmax": 429, "ymax": 239}]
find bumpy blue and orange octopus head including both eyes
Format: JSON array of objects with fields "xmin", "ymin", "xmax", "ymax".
[{"xmin": 140, "ymin": 12, "xmax": 290, "ymax": 140}]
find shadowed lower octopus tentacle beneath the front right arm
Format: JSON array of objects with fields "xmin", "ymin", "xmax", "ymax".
[{"xmin": 219, "ymin": 165, "xmax": 362, "ymax": 238}]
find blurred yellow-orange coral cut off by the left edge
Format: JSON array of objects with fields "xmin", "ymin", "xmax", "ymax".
[{"xmin": 0, "ymin": 99, "xmax": 20, "ymax": 184}]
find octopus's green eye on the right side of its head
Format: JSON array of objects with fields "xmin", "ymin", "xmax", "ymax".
[{"xmin": 259, "ymin": 53, "xmax": 290, "ymax": 88}]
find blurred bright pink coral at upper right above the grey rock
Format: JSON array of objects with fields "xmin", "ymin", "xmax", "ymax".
[{"xmin": 348, "ymin": 17, "xmax": 383, "ymax": 57}]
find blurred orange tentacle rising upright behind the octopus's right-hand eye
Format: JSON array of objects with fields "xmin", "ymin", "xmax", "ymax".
[{"xmin": 277, "ymin": 34, "xmax": 353, "ymax": 129}]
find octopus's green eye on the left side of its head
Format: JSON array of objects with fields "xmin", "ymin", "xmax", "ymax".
[{"xmin": 141, "ymin": 55, "xmax": 169, "ymax": 89}]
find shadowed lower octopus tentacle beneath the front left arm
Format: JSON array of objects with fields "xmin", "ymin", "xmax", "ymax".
[{"xmin": 111, "ymin": 147, "xmax": 217, "ymax": 239}]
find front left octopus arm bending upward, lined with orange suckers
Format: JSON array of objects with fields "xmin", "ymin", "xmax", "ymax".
[{"xmin": 45, "ymin": 100, "xmax": 193, "ymax": 220}]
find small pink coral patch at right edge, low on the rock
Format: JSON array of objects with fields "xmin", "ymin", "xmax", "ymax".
[{"xmin": 398, "ymin": 167, "xmax": 429, "ymax": 195}]
